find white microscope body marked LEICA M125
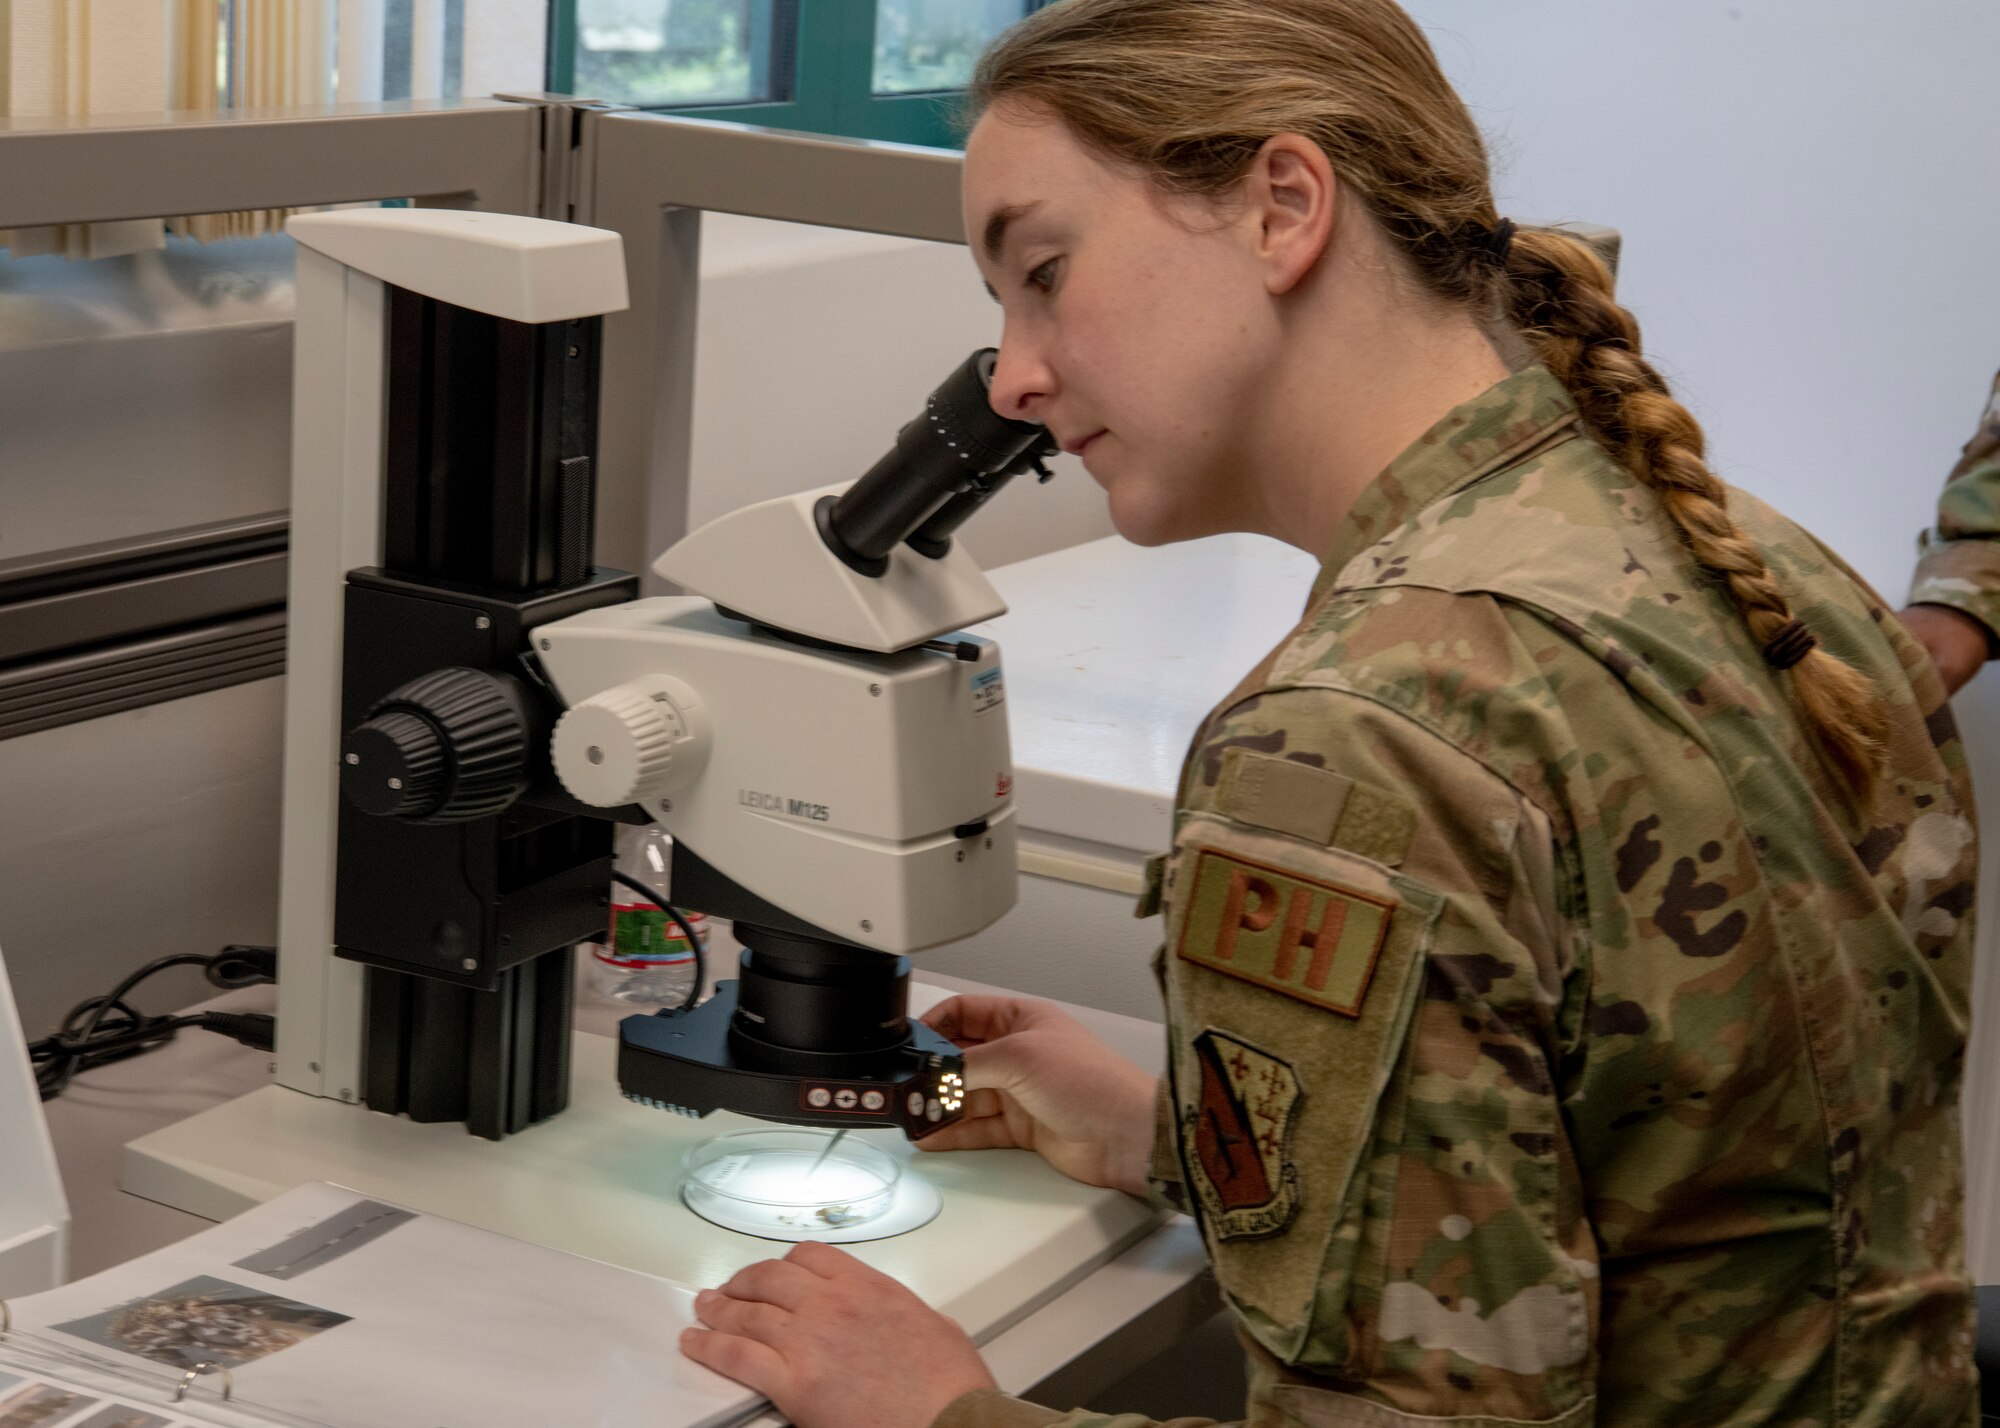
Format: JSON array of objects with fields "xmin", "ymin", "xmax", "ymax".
[{"xmin": 536, "ymin": 596, "xmax": 1018, "ymax": 954}]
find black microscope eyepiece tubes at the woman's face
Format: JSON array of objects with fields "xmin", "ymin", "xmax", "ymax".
[{"xmin": 820, "ymin": 348, "xmax": 1048, "ymax": 576}]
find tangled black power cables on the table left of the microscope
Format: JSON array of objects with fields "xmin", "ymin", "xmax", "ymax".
[{"xmin": 28, "ymin": 942, "xmax": 278, "ymax": 1100}]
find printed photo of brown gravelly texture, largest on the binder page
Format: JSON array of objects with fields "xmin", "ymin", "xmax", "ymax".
[{"xmin": 53, "ymin": 1274, "xmax": 348, "ymax": 1368}]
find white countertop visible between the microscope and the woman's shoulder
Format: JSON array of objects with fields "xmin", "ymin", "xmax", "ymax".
[{"xmin": 978, "ymin": 536, "xmax": 1320, "ymax": 852}]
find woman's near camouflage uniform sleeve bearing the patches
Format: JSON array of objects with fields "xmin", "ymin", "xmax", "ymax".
[{"xmin": 938, "ymin": 688, "xmax": 1598, "ymax": 1428}]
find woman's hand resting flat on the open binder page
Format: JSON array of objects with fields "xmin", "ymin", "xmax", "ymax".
[{"xmin": 680, "ymin": 1240, "xmax": 994, "ymax": 1428}]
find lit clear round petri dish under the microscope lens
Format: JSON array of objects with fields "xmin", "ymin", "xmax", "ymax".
[{"xmin": 680, "ymin": 1126, "xmax": 902, "ymax": 1240}]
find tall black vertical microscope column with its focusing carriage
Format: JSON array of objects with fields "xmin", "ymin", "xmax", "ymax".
[{"xmin": 334, "ymin": 288, "xmax": 638, "ymax": 1140}]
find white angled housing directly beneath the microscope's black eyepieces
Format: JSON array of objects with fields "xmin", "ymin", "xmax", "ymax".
[{"xmin": 652, "ymin": 484, "xmax": 1006, "ymax": 652}]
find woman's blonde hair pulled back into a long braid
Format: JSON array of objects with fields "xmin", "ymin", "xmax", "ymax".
[{"xmin": 968, "ymin": 0, "xmax": 1888, "ymax": 802}]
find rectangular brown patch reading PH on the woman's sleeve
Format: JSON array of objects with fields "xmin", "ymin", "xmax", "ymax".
[{"xmin": 1176, "ymin": 848, "xmax": 1396, "ymax": 1016}]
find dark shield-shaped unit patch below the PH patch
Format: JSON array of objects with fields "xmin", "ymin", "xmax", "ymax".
[{"xmin": 1180, "ymin": 1030, "xmax": 1300, "ymax": 1240}]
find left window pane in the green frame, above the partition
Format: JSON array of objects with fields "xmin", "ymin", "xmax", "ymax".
[{"xmin": 576, "ymin": 0, "xmax": 782, "ymax": 104}]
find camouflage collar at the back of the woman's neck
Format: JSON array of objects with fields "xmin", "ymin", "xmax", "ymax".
[{"xmin": 1308, "ymin": 362, "xmax": 1580, "ymax": 608}]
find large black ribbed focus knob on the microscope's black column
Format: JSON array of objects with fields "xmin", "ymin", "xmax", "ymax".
[{"xmin": 340, "ymin": 668, "xmax": 532, "ymax": 824}]
